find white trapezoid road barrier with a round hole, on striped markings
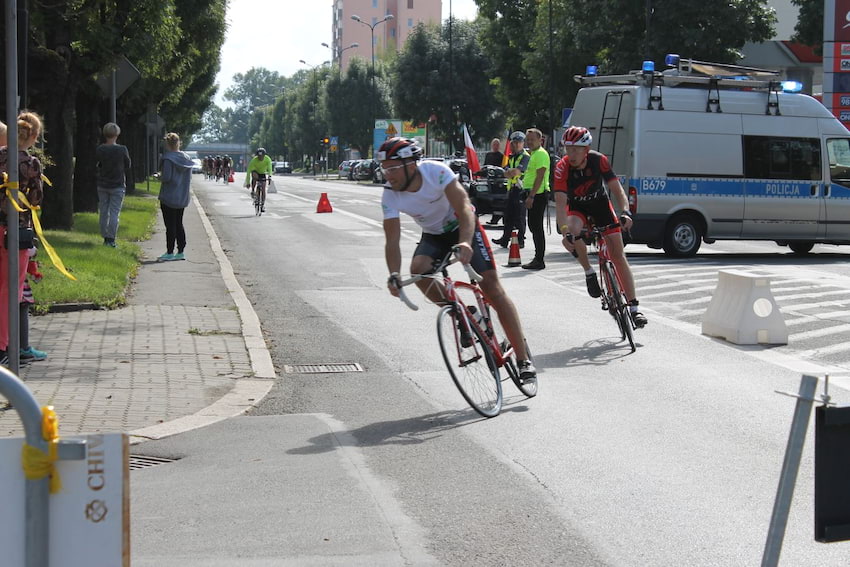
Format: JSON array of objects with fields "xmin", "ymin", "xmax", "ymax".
[{"xmin": 702, "ymin": 270, "xmax": 788, "ymax": 345}]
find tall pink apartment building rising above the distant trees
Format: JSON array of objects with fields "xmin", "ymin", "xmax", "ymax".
[{"xmin": 331, "ymin": 0, "xmax": 443, "ymax": 71}]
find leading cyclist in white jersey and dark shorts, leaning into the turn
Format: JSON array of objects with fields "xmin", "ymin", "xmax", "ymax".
[{"xmin": 376, "ymin": 138, "xmax": 537, "ymax": 381}]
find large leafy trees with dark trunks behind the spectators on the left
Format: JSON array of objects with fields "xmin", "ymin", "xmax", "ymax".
[{"xmin": 0, "ymin": 0, "xmax": 227, "ymax": 228}]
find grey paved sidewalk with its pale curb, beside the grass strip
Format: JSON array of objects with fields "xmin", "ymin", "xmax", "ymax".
[{"xmin": 0, "ymin": 184, "xmax": 274, "ymax": 442}]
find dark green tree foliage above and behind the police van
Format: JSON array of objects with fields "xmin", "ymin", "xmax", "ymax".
[{"xmin": 476, "ymin": 0, "xmax": 776, "ymax": 139}]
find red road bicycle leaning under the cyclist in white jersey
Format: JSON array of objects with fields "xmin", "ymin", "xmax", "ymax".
[{"xmin": 395, "ymin": 247, "xmax": 537, "ymax": 417}]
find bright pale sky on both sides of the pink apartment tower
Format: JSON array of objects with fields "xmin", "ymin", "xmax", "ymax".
[{"xmin": 216, "ymin": 0, "xmax": 477, "ymax": 106}]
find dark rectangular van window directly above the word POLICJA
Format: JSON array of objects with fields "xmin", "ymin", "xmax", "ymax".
[{"xmin": 744, "ymin": 136, "xmax": 822, "ymax": 181}]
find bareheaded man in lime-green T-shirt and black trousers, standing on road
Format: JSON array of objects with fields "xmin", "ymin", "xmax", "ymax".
[{"xmin": 522, "ymin": 128, "xmax": 550, "ymax": 270}]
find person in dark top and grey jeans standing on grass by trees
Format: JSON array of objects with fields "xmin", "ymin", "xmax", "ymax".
[{"xmin": 95, "ymin": 122, "xmax": 130, "ymax": 248}]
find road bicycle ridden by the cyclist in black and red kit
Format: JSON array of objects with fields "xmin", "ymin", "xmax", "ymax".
[{"xmin": 565, "ymin": 222, "xmax": 637, "ymax": 352}]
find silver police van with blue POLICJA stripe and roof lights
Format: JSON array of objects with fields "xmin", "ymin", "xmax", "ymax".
[{"xmin": 569, "ymin": 56, "xmax": 850, "ymax": 257}]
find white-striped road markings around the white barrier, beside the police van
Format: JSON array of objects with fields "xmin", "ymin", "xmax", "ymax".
[{"xmin": 540, "ymin": 254, "xmax": 850, "ymax": 371}]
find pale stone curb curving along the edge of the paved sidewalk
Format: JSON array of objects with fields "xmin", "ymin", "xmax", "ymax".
[{"xmin": 128, "ymin": 191, "xmax": 277, "ymax": 445}]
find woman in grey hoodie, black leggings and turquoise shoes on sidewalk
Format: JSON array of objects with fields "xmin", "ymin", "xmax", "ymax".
[{"xmin": 157, "ymin": 132, "xmax": 193, "ymax": 262}]
